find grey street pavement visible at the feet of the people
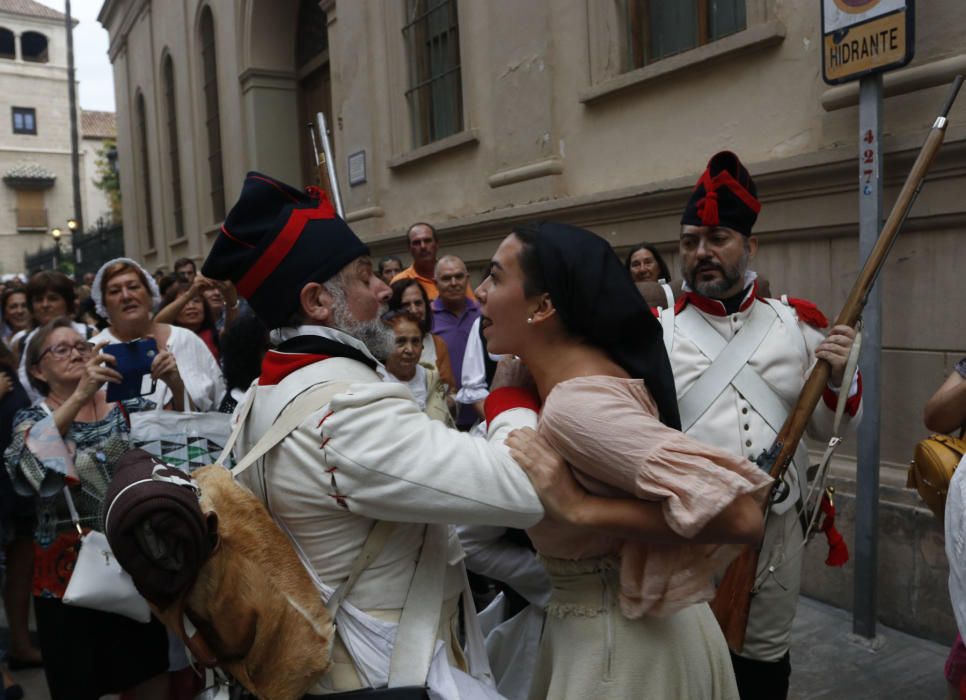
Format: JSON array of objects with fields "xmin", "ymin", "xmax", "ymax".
[{"xmin": 0, "ymin": 598, "xmax": 951, "ymax": 700}]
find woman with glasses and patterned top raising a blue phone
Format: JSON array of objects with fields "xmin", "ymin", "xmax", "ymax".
[{"xmin": 6, "ymin": 318, "xmax": 173, "ymax": 700}]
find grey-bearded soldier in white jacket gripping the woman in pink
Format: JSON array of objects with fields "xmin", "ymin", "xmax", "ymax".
[{"xmin": 203, "ymin": 173, "xmax": 543, "ymax": 698}]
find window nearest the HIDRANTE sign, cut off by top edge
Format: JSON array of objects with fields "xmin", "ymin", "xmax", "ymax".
[{"xmin": 621, "ymin": 0, "xmax": 746, "ymax": 70}]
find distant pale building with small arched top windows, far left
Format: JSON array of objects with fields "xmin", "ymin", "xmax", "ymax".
[{"xmin": 0, "ymin": 0, "xmax": 109, "ymax": 273}]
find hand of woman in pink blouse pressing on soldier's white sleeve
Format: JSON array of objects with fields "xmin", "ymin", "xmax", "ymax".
[{"xmin": 506, "ymin": 428, "xmax": 588, "ymax": 525}]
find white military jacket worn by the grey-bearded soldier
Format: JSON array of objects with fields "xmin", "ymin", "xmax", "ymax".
[{"xmin": 236, "ymin": 326, "xmax": 543, "ymax": 610}]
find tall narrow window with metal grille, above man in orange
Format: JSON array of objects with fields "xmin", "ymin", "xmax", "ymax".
[{"xmin": 403, "ymin": 0, "xmax": 463, "ymax": 147}]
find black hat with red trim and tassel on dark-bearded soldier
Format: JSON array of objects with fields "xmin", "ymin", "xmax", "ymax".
[{"xmin": 681, "ymin": 151, "xmax": 761, "ymax": 236}]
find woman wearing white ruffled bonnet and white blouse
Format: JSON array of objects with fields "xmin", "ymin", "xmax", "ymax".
[{"xmin": 91, "ymin": 258, "xmax": 225, "ymax": 411}]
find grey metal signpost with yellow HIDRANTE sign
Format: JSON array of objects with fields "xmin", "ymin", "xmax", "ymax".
[{"xmin": 822, "ymin": 0, "xmax": 915, "ymax": 639}]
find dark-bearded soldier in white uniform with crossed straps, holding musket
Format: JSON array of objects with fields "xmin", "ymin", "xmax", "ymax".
[{"xmin": 660, "ymin": 152, "xmax": 861, "ymax": 700}]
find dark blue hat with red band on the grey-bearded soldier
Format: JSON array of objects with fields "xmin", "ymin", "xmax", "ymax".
[{"xmin": 201, "ymin": 172, "xmax": 369, "ymax": 328}]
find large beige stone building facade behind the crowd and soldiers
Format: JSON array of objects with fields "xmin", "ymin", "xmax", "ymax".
[{"xmin": 100, "ymin": 0, "xmax": 966, "ymax": 637}]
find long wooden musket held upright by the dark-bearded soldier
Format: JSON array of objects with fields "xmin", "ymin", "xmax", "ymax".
[{"xmin": 711, "ymin": 75, "xmax": 963, "ymax": 653}]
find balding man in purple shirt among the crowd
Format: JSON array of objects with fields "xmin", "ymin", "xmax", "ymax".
[{"xmin": 432, "ymin": 255, "xmax": 480, "ymax": 430}]
